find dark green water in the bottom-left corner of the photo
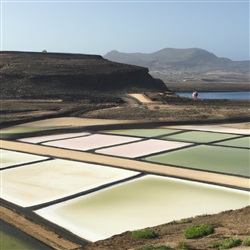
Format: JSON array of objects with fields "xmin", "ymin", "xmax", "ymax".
[{"xmin": 0, "ymin": 221, "xmax": 52, "ymax": 250}]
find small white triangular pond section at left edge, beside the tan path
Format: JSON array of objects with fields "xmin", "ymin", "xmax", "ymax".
[{"xmin": 0, "ymin": 149, "xmax": 48, "ymax": 169}]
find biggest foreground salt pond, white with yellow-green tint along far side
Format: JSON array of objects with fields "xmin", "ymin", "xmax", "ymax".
[{"xmin": 36, "ymin": 175, "xmax": 249, "ymax": 241}]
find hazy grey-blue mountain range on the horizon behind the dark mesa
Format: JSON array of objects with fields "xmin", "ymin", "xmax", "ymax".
[{"xmin": 104, "ymin": 48, "xmax": 250, "ymax": 81}]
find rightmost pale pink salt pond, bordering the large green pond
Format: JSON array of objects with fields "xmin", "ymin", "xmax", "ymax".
[{"xmin": 95, "ymin": 139, "xmax": 190, "ymax": 158}]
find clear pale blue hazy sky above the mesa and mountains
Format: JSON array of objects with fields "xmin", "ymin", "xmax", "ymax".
[{"xmin": 0, "ymin": 0, "xmax": 250, "ymax": 60}]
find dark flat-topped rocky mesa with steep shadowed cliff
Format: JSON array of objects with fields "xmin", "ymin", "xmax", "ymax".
[{"xmin": 0, "ymin": 51, "xmax": 167, "ymax": 99}]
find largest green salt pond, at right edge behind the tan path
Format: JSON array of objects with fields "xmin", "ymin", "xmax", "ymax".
[{"xmin": 145, "ymin": 145, "xmax": 250, "ymax": 177}]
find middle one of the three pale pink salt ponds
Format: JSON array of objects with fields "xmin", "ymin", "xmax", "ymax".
[{"xmin": 44, "ymin": 134, "xmax": 141, "ymax": 151}]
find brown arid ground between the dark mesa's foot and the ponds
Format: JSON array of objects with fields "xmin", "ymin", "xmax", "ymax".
[{"xmin": 0, "ymin": 89, "xmax": 250, "ymax": 128}]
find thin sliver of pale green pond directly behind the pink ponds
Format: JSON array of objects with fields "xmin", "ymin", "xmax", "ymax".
[{"xmin": 102, "ymin": 128, "xmax": 180, "ymax": 137}]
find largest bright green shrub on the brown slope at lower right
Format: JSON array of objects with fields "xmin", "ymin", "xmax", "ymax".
[{"xmin": 184, "ymin": 224, "xmax": 214, "ymax": 239}]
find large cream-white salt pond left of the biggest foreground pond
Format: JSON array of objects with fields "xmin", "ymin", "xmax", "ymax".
[{"xmin": 1, "ymin": 159, "xmax": 138, "ymax": 207}]
